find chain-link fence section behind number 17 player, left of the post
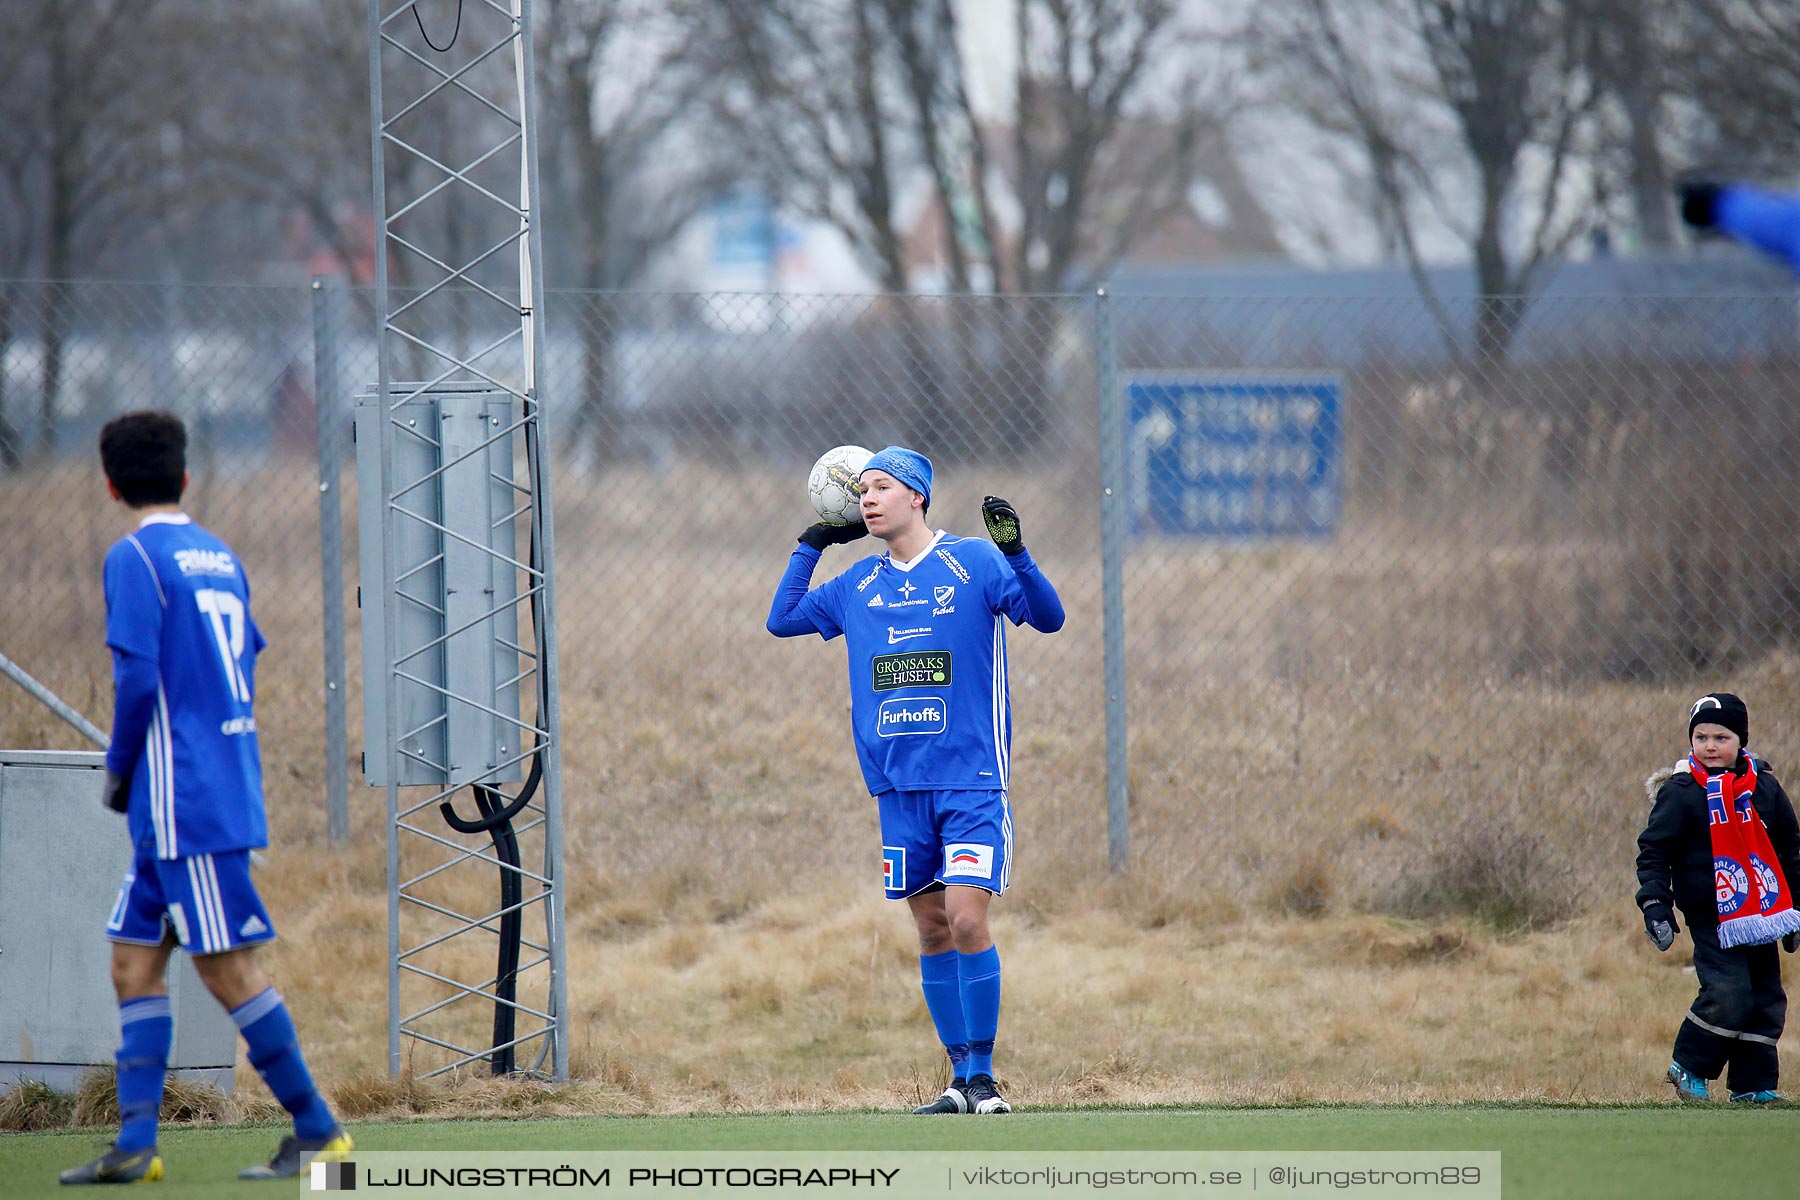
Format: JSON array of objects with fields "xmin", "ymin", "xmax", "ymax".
[{"xmin": 0, "ymin": 281, "xmax": 324, "ymax": 763}]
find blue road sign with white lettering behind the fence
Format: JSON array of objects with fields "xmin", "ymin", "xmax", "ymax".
[{"xmin": 1125, "ymin": 371, "xmax": 1343, "ymax": 538}]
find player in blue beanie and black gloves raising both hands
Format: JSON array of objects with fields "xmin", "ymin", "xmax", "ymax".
[{"xmin": 769, "ymin": 446, "xmax": 1062, "ymax": 1114}]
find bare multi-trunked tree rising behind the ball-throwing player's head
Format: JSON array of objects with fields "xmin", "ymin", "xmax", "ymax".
[{"xmin": 716, "ymin": 0, "xmax": 1220, "ymax": 448}]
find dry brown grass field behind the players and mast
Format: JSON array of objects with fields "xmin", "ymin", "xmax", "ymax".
[{"xmin": 0, "ymin": 468, "xmax": 1800, "ymax": 1117}]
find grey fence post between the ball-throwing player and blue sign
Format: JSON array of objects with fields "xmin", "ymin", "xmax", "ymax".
[{"xmin": 1094, "ymin": 288, "xmax": 1130, "ymax": 871}]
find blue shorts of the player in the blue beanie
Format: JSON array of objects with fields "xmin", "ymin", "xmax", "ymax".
[{"xmin": 875, "ymin": 792, "xmax": 1012, "ymax": 900}]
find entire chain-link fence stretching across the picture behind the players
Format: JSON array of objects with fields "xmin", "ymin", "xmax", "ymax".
[{"xmin": 0, "ymin": 277, "xmax": 1800, "ymax": 925}]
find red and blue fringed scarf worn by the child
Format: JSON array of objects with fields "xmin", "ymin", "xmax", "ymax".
[{"xmin": 1681, "ymin": 754, "xmax": 1800, "ymax": 946}]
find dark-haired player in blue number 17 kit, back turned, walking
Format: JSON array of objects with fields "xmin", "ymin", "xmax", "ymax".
[{"xmin": 61, "ymin": 412, "xmax": 353, "ymax": 1184}]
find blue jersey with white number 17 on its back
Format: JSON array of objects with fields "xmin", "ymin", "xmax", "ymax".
[{"xmin": 104, "ymin": 513, "xmax": 268, "ymax": 858}]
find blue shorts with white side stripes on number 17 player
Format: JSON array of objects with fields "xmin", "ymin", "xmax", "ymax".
[{"xmin": 106, "ymin": 844, "xmax": 275, "ymax": 955}]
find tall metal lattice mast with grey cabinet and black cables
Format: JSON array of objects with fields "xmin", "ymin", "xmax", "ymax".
[{"xmin": 356, "ymin": 0, "xmax": 569, "ymax": 1079}]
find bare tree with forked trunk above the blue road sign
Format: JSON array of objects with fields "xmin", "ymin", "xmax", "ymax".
[{"xmin": 1251, "ymin": 0, "xmax": 1600, "ymax": 362}]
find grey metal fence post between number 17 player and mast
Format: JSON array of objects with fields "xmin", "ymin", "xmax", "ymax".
[{"xmin": 313, "ymin": 275, "xmax": 349, "ymax": 846}]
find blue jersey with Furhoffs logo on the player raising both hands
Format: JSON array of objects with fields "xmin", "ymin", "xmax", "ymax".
[{"xmin": 769, "ymin": 531, "xmax": 1062, "ymax": 795}]
